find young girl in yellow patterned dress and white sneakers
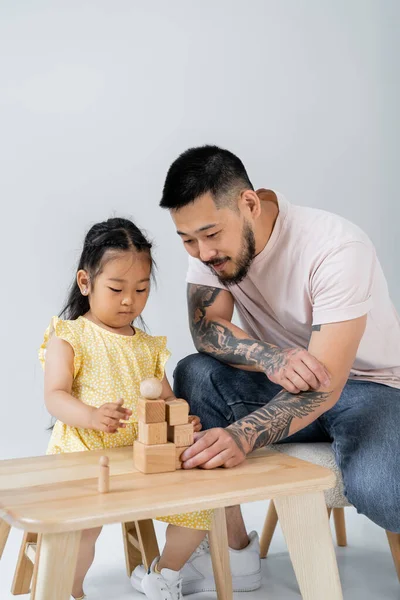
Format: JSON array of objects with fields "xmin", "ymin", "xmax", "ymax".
[{"xmin": 39, "ymin": 219, "xmax": 212, "ymax": 600}]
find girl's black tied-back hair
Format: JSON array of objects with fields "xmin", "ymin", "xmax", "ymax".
[{"xmin": 59, "ymin": 218, "xmax": 154, "ymax": 321}]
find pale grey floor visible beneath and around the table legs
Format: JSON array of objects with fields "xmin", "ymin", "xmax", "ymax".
[{"xmin": 0, "ymin": 502, "xmax": 400, "ymax": 600}]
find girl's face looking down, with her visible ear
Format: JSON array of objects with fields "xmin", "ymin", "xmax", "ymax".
[{"xmin": 77, "ymin": 250, "xmax": 151, "ymax": 333}]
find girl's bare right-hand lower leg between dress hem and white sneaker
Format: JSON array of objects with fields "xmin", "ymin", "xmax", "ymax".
[{"xmin": 157, "ymin": 525, "xmax": 207, "ymax": 571}]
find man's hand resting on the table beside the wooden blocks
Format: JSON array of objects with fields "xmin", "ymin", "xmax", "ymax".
[{"xmin": 181, "ymin": 427, "xmax": 250, "ymax": 469}]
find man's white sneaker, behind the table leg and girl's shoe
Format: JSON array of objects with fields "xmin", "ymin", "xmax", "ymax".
[{"xmin": 131, "ymin": 531, "xmax": 261, "ymax": 595}]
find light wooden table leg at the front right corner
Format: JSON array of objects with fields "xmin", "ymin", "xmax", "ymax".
[{"xmin": 274, "ymin": 492, "xmax": 343, "ymax": 600}]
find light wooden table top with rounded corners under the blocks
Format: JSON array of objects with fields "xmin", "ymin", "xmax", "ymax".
[{"xmin": 0, "ymin": 446, "xmax": 335, "ymax": 533}]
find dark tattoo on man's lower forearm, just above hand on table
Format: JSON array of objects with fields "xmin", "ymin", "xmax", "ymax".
[{"xmin": 227, "ymin": 390, "xmax": 331, "ymax": 451}]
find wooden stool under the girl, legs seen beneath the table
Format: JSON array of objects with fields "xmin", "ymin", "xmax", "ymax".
[{"xmin": 6, "ymin": 519, "xmax": 160, "ymax": 600}]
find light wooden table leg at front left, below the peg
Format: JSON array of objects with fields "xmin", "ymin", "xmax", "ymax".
[{"xmin": 35, "ymin": 531, "xmax": 81, "ymax": 600}]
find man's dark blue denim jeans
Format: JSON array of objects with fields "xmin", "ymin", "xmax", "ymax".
[{"xmin": 174, "ymin": 354, "xmax": 400, "ymax": 533}]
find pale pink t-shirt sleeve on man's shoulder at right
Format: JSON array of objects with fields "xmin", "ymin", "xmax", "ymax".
[{"xmin": 311, "ymin": 241, "xmax": 376, "ymax": 325}]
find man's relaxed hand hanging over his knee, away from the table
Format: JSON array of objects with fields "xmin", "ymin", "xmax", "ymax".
[{"xmin": 265, "ymin": 348, "xmax": 331, "ymax": 394}]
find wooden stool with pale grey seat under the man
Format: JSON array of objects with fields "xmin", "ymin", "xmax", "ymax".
[{"xmin": 260, "ymin": 443, "xmax": 400, "ymax": 581}]
